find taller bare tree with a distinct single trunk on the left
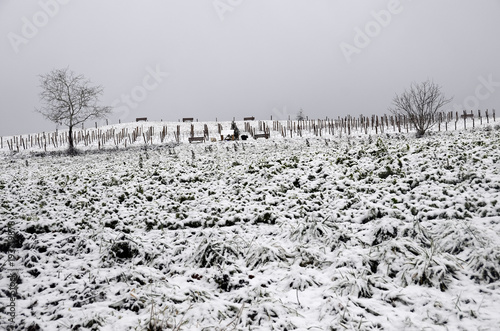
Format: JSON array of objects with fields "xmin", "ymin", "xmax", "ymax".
[{"xmin": 36, "ymin": 68, "xmax": 112, "ymax": 154}]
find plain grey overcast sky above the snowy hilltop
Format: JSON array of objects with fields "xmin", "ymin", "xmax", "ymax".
[{"xmin": 0, "ymin": 0, "xmax": 500, "ymax": 136}]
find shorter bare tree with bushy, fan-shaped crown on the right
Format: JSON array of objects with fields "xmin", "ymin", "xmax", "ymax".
[{"xmin": 390, "ymin": 80, "xmax": 453, "ymax": 137}]
